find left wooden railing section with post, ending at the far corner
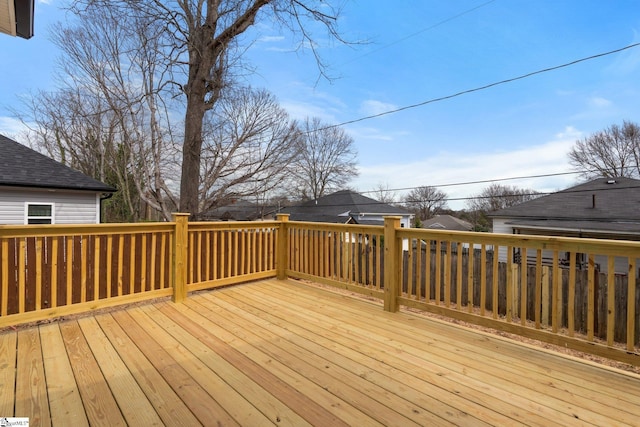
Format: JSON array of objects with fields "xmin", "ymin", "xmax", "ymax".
[{"xmin": 0, "ymin": 214, "xmax": 280, "ymax": 327}]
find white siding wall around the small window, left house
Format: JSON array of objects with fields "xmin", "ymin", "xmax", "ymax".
[{"xmin": 0, "ymin": 187, "xmax": 100, "ymax": 225}]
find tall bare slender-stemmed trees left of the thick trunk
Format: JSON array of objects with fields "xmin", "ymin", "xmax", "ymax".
[{"xmin": 18, "ymin": 7, "xmax": 179, "ymax": 220}]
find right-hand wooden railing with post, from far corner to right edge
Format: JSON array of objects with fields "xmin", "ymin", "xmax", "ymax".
[{"xmin": 286, "ymin": 218, "xmax": 640, "ymax": 365}]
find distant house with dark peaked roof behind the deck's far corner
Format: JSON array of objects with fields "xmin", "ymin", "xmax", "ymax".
[{"xmin": 282, "ymin": 190, "xmax": 413, "ymax": 228}]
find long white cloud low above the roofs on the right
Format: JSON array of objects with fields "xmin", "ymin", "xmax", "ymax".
[{"xmin": 353, "ymin": 127, "xmax": 582, "ymax": 209}]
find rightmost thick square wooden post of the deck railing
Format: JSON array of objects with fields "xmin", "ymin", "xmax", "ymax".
[{"xmin": 384, "ymin": 216, "xmax": 401, "ymax": 312}]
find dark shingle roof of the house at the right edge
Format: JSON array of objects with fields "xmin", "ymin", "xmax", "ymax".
[{"xmin": 489, "ymin": 177, "xmax": 640, "ymax": 233}]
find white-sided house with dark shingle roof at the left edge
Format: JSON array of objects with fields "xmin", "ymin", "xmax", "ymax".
[{"xmin": 0, "ymin": 135, "xmax": 116, "ymax": 224}]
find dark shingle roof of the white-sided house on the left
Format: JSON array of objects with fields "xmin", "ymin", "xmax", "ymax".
[{"xmin": 0, "ymin": 135, "xmax": 116, "ymax": 193}]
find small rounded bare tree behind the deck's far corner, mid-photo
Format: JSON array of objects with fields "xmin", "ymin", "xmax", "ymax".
[{"xmin": 292, "ymin": 117, "xmax": 358, "ymax": 199}]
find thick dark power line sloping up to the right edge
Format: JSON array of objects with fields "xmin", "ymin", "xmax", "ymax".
[{"xmin": 314, "ymin": 43, "xmax": 640, "ymax": 133}]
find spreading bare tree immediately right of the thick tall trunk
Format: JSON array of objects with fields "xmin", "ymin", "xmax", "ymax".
[{"xmin": 199, "ymin": 88, "xmax": 300, "ymax": 214}]
